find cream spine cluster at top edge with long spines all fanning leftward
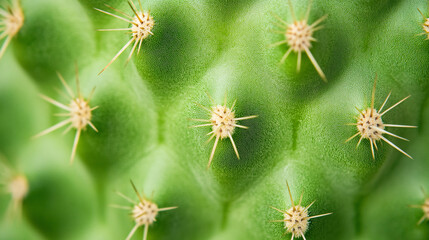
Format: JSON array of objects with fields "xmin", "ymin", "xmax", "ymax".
[{"xmin": 95, "ymin": 0, "xmax": 155, "ymax": 75}]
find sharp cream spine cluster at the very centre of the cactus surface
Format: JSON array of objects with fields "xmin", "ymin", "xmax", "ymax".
[{"xmin": 191, "ymin": 93, "xmax": 257, "ymax": 168}]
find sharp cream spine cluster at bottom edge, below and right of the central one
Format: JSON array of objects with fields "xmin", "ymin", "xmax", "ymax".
[{"xmin": 271, "ymin": 181, "xmax": 332, "ymax": 240}]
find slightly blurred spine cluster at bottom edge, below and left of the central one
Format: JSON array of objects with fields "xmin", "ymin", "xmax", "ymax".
[{"xmin": 111, "ymin": 181, "xmax": 177, "ymax": 240}]
